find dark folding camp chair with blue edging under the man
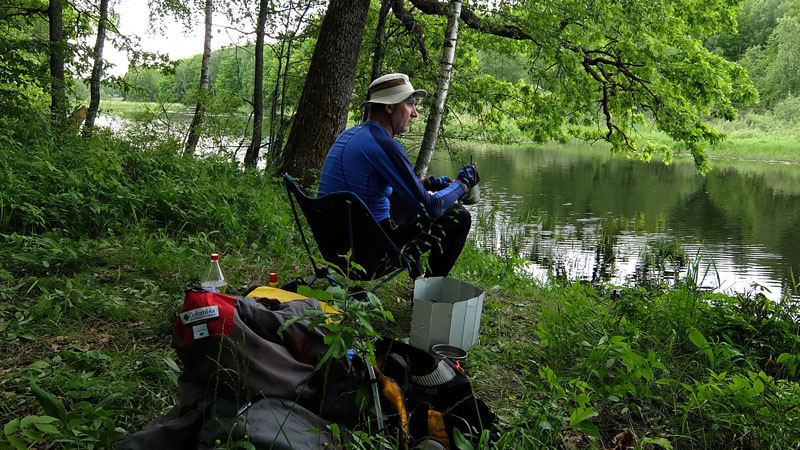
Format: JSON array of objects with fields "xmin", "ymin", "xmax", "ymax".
[{"xmin": 283, "ymin": 174, "xmax": 411, "ymax": 291}]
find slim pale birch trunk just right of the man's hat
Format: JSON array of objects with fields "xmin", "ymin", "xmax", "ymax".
[{"xmin": 414, "ymin": 0, "xmax": 461, "ymax": 177}]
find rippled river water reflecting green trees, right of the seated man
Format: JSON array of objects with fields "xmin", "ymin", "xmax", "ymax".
[{"xmin": 430, "ymin": 142, "xmax": 800, "ymax": 300}]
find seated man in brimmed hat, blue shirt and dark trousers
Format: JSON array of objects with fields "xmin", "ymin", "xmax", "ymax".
[{"xmin": 319, "ymin": 73, "xmax": 479, "ymax": 279}]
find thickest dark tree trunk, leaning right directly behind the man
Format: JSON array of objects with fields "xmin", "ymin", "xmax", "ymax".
[{"xmin": 283, "ymin": 0, "xmax": 369, "ymax": 184}]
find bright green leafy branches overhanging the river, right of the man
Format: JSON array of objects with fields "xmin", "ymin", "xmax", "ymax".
[{"xmin": 362, "ymin": 0, "xmax": 756, "ymax": 171}]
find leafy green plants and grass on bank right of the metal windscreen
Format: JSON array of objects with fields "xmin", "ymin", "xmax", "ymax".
[{"xmin": 462, "ymin": 258, "xmax": 800, "ymax": 449}]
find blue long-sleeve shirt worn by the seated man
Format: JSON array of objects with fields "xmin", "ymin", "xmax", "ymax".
[{"xmin": 319, "ymin": 121, "xmax": 464, "ymax": 221}]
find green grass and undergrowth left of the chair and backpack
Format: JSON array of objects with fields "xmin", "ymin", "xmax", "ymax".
[{"xmin": 0, "ymin": 125, "xmax": 301, "ymax": 448}]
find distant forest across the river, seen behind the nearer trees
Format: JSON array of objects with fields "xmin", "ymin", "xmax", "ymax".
[{"xmin": 108, "ymin": 0, "xmax": 800, "ymax": 114}]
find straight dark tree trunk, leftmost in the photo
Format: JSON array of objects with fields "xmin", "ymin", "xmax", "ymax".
[{"xmin": 47, "ymin": 0, "xmax": 67, "ymax": 128}]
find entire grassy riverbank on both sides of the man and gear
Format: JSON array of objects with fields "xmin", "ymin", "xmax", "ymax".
[{"xmin": 0, "ymin": 125, "xmax": 800, "ymax": 449}]
